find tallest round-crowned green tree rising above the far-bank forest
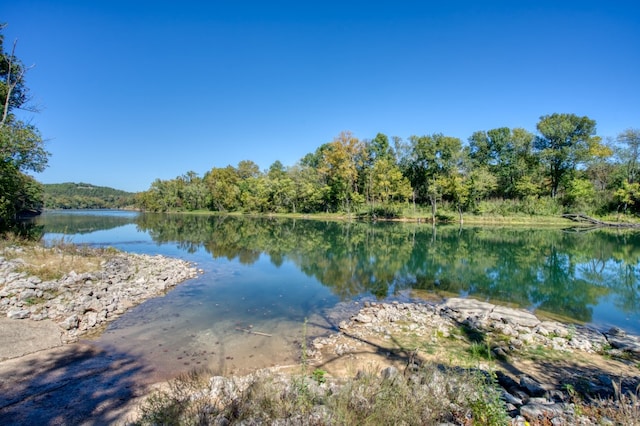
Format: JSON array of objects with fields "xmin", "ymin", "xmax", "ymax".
[{"xmin": 535, "ymin": 113, "xmax": 600, "ymax": 198}]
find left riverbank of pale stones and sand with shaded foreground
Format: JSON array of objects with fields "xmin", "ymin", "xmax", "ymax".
[{"xmin": 0, "ymin": 242, "xmax": 197, "ymax": 425}]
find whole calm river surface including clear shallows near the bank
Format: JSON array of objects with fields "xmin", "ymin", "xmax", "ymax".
[{"xmin": 33, "ymin": 211, "xmax": 640, "ymax": 371}]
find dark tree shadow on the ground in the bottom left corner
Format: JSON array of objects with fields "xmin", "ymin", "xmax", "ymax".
[{"xmin": 0, "ymin": 343, "xmax": 152, "ymax": 425}]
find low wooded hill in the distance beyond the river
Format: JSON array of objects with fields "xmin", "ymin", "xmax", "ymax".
[{"xmin": 43, "ymin": 182, "xmax": 135, "ymax": 209}]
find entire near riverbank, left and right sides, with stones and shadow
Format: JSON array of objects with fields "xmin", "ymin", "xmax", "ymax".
[{"xmin": 0, "ymin": 241, "xmax": 640, "ymax": 424}]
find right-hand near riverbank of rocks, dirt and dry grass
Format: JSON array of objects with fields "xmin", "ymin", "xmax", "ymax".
[{"xmin": 134, "ymin": 298, "xmax": 640, "ymax": 425}]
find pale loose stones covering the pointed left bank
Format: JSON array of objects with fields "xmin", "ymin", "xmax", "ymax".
[{"xmin": 0, "ymin": 248, "xmax": 197, "ymax": 343}]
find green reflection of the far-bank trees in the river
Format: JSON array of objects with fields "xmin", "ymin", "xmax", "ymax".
[{"xmin": 137, "ymin": 214, "xmax": 640, "ymax": 331}]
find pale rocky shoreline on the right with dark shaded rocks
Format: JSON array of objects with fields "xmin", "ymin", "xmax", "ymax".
[{"xmin": 309, "ymin": 298, "xmax": 640, "ymax": 425}]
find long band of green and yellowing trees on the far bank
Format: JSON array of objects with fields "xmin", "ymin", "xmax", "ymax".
[{"xmin": 135, "ymin": 113, "xmax": 640, "ymax": 221}]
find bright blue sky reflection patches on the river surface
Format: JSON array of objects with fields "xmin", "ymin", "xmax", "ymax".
[{"xmin": 40, "ymin": 211, "xmax": 640, "ymax": 333}]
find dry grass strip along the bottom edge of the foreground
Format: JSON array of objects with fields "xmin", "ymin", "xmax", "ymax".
[{"xmin": 134, "ymin": 365, "xmax": 508, "ymax": 425}]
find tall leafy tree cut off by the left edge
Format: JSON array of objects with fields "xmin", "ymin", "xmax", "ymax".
[{"xmin": 0, "ymin": 25, "xmax": 49, "ymax": 228}]
